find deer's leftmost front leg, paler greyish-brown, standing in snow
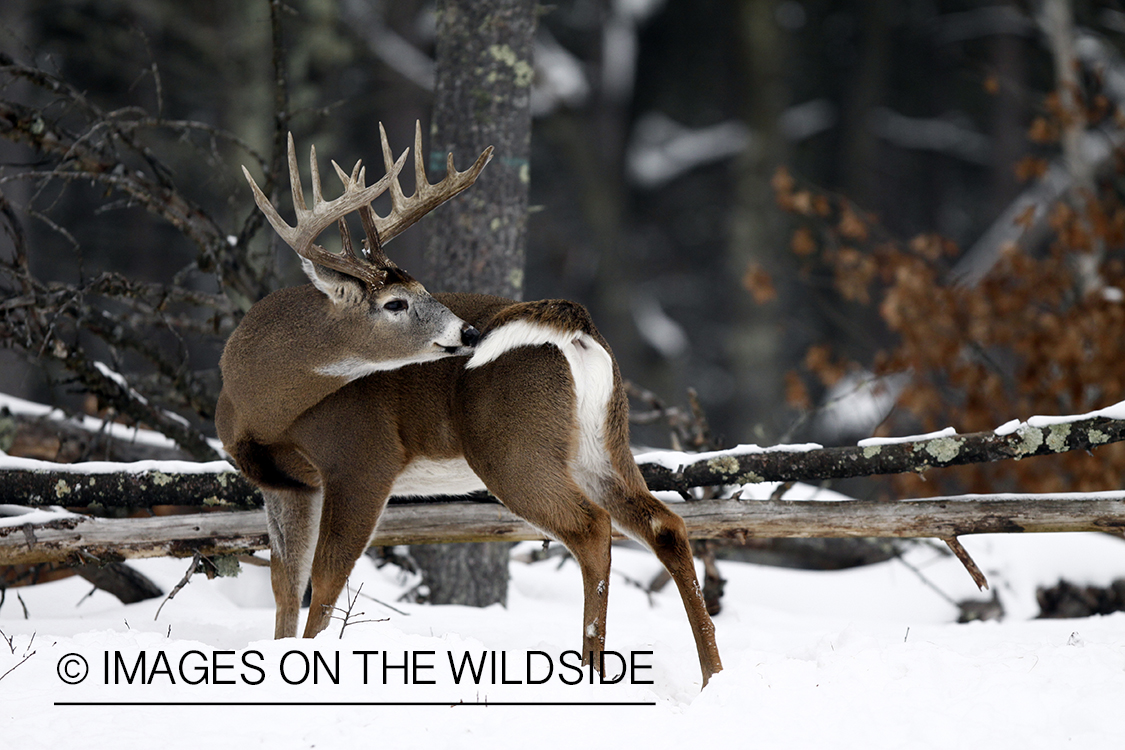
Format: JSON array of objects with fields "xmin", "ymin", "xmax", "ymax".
[{"xmin": 262, "ymin": 488, "xmax": 323, "ymax": 638}]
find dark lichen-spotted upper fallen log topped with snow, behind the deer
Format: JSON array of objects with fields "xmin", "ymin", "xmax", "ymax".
[{"xmin": 0, "ymin": 404, "xmax": 1125, "ymax": 509}]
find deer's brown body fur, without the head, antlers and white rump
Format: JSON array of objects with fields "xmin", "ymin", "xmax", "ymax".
[{"xmin": 216, "ymin": 287, "xmax": 722, "ymax": 684}]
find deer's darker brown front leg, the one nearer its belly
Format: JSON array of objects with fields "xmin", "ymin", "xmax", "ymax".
[{"xmin": 305, "ymin": 479, "xmax": 392, "ymax": 638}]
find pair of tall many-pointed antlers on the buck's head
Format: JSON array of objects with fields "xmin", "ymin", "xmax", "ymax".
[{"xmin": 242, "ymin": 123, "xmax": 493, "ymax": 288}]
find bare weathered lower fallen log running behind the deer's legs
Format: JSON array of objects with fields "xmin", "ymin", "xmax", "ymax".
[{"xmin": 0, "ymin": 491, "xmax": 1125, "ymax": 564}]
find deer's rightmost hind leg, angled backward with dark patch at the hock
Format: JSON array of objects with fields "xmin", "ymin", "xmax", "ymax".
[{"xmin": 602, "ymin": 482, "xmax": 722, "ymax": 686}]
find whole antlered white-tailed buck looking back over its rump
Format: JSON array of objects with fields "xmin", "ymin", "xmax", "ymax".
[{"xmin": 215, "ymin": 125, "xmax": 722, "ymax": 686}]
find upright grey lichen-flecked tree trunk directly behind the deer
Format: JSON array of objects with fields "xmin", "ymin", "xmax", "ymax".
[{"xmin": 411, "ymin": 0, "xmax": 537, "ymax": 606}]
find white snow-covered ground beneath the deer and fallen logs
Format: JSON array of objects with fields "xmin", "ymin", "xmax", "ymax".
[{"xmin": 0, "ymin": 534, "xmax": 1125, "ymax": 750}]
